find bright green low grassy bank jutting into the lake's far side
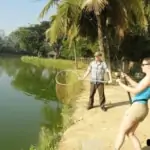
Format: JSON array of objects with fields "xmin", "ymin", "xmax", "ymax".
[{"xmin": 21, "ymin": 56, "xmax": 86, "ymax": 69}]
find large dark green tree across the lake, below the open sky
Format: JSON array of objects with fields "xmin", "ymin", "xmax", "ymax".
[{"xmin": 9, "ymin": 21, "xmax": 50, "ymax": 57}]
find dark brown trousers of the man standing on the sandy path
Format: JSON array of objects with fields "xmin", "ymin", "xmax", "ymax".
[{"xmin": 88, "ymin": 82, "xmax": 106, "ymax": 109}]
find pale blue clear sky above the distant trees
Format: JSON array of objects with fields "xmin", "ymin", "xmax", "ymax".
[{"xmin": 0, "ymin": 0, "xmax": 56, "ymax": 35}]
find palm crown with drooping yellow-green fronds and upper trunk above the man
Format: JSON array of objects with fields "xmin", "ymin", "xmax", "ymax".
[{"xmin": 39, "ymin": 0, "xmax": 147, "ymax": 70}]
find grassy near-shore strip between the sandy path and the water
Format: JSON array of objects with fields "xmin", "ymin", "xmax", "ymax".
[{"xmin": 29, "ymin": 75, "xmax": 83, "ymax": 150}]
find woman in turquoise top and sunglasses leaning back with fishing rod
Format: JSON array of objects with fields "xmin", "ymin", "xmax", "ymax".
[{"xmin": 115, "ymin": 58, "xmax": 150, "ymax": 150}]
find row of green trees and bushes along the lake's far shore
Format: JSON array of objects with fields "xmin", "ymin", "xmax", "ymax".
[{"xmin": 0, "ymin": 21, "xmax": 98, "ymax": 59}]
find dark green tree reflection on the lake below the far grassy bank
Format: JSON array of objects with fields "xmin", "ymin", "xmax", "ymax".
[{"xmin": 12, "ymin": 66, "xmax": 57, "ymax": 100}]
